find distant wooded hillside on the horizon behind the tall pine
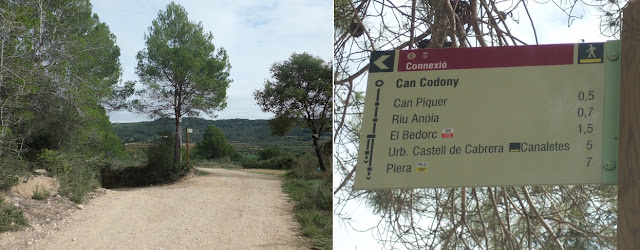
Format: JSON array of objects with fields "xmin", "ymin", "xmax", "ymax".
[{"xmin": 113, "ymin": 118, "xmax": 331, "ymax": 152}]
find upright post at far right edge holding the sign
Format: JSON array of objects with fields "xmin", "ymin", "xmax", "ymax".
[{"xmin": 618, "ymin": 1, "xmax": 640, "ymax": 249}]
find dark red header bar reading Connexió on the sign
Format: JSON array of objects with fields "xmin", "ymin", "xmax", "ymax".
[{"xmin": 398, "ymin": 44, "xmax": 575, "ymax": 72}]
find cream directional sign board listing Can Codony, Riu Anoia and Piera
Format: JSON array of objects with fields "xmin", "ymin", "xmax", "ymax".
[{"xmin": 354, "ymin": 41, "xmax": 620, "ymax": 189}]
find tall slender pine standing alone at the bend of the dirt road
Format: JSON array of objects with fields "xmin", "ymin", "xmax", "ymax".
[{"xmin": 135, "ymin": 2, "xmax": 231, "ymax": 167}]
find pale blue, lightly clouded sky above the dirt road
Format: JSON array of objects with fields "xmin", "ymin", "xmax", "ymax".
[{"xmin": 91, "ymin": 0, "xmax": 333, "ymax": 123}]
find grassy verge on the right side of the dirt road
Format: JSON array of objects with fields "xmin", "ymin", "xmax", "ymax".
[{"xmin": 282, "ymin": 157, "xmax": 333, "ymax": 249}]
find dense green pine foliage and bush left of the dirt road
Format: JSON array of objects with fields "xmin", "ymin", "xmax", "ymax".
[{"xmin": 0, "ymin": 0, "xmax": 127, "ymax": 202}]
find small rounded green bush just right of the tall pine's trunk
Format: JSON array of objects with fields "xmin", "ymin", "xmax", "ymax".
[{"xmin": 195, "ymin": 125, "xmax": 233, "ymax": 159}]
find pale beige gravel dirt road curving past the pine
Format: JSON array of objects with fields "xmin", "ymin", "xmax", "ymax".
[{"xmin": 0, "ymin": 169, "xmax": 308, "ymax": 249}]
